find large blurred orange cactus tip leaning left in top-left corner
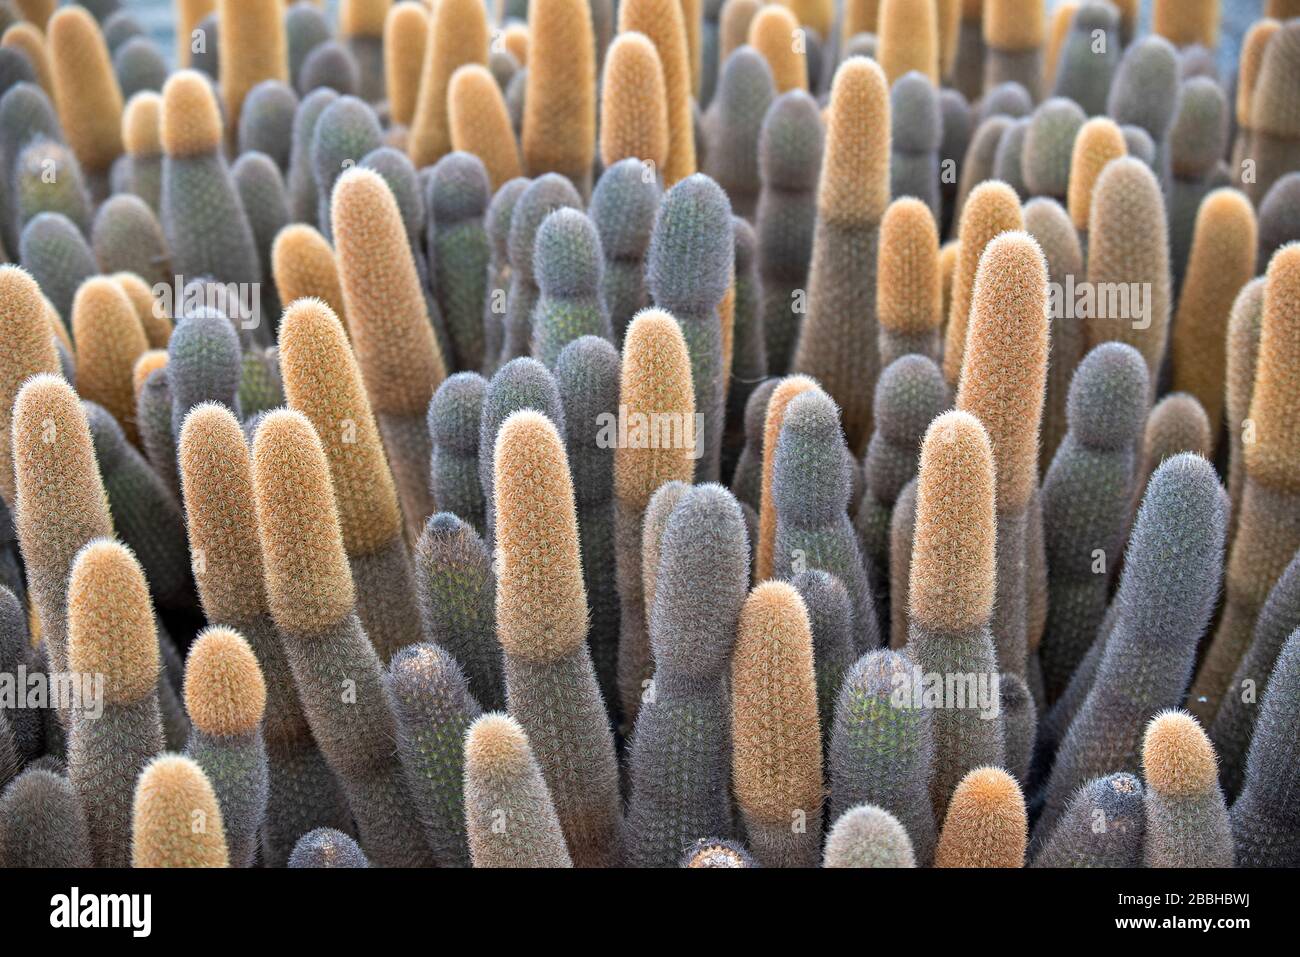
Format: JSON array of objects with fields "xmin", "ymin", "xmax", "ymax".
[{"xmin": 47, "ymin": 7, "xmax": 122, "ymax": 173}]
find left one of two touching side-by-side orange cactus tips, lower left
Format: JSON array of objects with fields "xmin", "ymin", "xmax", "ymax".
[{"xmin": 177, "ymin": 402, "xmax": 267, "ymax": 622}]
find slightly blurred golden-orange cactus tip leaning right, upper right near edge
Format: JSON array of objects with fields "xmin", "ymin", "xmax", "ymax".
[{"xmin": 1171, "ymin": 189, "xmax": 1258, "ymax": 434}]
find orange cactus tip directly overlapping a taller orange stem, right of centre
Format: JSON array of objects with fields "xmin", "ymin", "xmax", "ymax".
[{"xmin": 907, "ymin": 411, "xmax": 997, "ymax": 631}]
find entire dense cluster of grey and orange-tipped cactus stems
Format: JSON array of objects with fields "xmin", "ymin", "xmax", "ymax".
[{"xmin": 0, "ymin": 0, "xmax": 1300, "ymax": 867}]
